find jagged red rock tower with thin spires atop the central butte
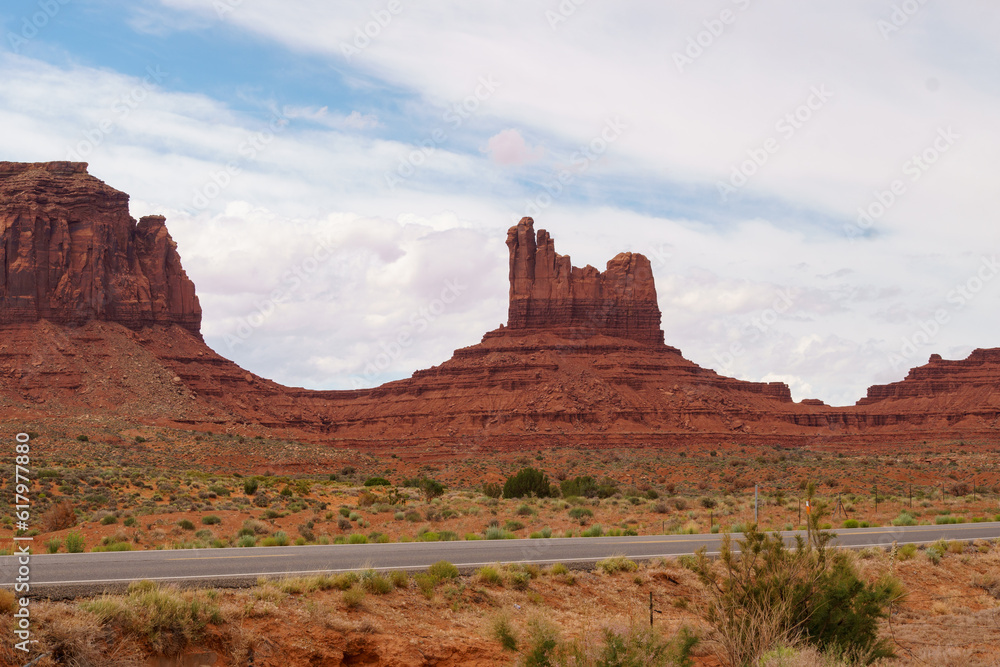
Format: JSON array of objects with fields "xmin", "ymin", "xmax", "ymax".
[{"xmin": 507, "ymin": 218, "xmax": 663, "ymax": 345}]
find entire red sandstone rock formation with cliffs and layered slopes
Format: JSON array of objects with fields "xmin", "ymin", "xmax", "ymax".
[{"xmin": 0, "ymin": 162, "xmax": 1000, "ymax": 452}]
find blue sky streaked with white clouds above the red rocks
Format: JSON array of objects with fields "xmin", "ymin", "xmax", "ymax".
[{"xmin": 0, "ymin": 0, "xmax": 1000, "ymax": 405}]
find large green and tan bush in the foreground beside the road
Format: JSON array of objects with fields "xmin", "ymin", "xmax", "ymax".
[{"xmin": 694, "ymin": 518, "xmax": 902, "ymax": 665}]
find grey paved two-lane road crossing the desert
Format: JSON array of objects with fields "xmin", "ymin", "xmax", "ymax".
[{"xmin": 0, "ymin": 523, "xmax": 1000, "ymax": 592}]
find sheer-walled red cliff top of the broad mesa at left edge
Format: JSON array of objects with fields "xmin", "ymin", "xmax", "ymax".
[{"xmin": 0, "ymin": 162, "xmax": 201, "ymax": 336}]
